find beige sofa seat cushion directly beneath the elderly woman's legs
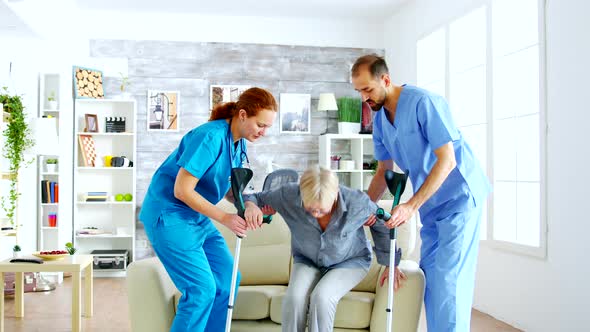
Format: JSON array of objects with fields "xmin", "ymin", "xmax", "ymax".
[{"xmin": 270, "ymin": 291, "xmax": 375, "ymax": 329}]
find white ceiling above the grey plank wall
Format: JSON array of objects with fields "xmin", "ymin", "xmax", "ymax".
[{"xmin": 0, "ymin": 0, "xmax": 412, "ymax": 42}]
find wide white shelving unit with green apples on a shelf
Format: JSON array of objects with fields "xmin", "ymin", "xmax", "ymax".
[{"xmin": 73, "ymin": 99, "xmax": 137, "ymax": 275}]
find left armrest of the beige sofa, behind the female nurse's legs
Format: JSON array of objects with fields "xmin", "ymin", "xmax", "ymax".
[{"xmin": 127, "ymin": 257, "xmax": 178, "ymax": 332}]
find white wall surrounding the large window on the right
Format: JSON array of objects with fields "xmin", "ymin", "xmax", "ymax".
[{"xmin": 384, "ymin": 0, "xmax": 590, "ymax": 331}]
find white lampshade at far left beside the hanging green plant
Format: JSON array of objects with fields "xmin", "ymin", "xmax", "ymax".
[{"xmin": 26, "ymin": 118, "xmax": 59, "ymax": 156}]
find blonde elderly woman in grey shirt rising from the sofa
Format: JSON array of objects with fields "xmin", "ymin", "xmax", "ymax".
[{"xmin": 244, "ymin": 166, "xmax": 404, "ymax": 332}]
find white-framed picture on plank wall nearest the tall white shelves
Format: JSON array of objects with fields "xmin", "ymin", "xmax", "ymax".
[{"xmin": 147, "ymin": 90, "xmax": 180, "ymax": 132}]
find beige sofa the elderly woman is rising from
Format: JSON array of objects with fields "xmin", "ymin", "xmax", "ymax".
[{"xmin": 127, "ymin": 200, "xmax": 424, "ymax": 332}]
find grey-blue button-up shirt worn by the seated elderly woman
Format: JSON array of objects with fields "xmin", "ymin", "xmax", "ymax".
[{"xmin": 244, "ymin": 183, "xmax": 389, "ymax": 269}]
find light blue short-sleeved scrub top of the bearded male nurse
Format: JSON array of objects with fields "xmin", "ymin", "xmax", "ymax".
[{"xmin": 373, "ymin": 85, "xmax": 491, "ymax": 216}]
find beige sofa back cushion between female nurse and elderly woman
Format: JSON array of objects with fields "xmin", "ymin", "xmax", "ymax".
[{"xmin": 215, "ymin": 200, "xmax": 291, "ymax": 285}]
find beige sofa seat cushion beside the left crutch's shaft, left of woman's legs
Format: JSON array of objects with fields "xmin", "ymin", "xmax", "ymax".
[{"xmin": 233, "ymin": 286, "xmax": 287, "ymax": 320}]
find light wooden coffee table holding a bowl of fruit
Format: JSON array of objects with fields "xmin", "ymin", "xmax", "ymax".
[{"xmin": 0, "ymin": 255, "xmax": 93, "ymax": 332}]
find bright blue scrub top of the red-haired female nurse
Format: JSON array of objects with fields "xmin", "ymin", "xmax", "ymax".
[{"xmin": 139, "ymin": 120, "xmax": 246, "ymax": 225}]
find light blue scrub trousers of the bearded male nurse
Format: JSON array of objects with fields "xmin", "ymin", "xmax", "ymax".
[{"xmin": 420, "ymin": 205, "xmax": 482, "ymax": 332}]
